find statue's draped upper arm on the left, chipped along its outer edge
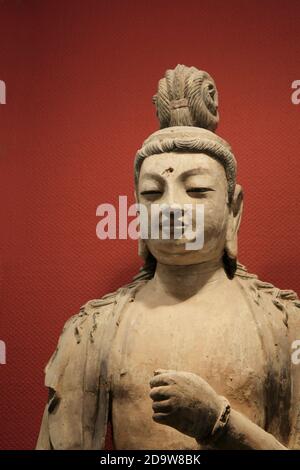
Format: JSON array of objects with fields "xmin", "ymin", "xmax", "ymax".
[{"xmin": 36, "ymin": 297, "xmax": 114, "ymax": 450}]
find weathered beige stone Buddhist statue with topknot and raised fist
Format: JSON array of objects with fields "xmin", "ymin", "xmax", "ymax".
[{"xmin": 37, "ymin": 65, "xmax": 300, "ymax": 450}]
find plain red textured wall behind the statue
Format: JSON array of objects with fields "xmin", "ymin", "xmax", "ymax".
[{"xmin": 0, "ymin": 0, "xmax": 300, "ymax": 449}]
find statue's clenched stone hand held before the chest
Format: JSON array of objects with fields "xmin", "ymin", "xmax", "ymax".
[{"xmin": 150, "ymin": 369, "xmax": 223, "ymax": 441}]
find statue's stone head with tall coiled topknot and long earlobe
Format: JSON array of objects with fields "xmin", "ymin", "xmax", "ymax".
[{"xmin": 134, "ymin": 65, "xmax": 243, "ymax": 277}]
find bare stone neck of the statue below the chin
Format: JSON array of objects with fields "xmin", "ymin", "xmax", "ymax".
[{"xmin": 152, "ymin": 260, "xmax": 227, "ymax": 300}]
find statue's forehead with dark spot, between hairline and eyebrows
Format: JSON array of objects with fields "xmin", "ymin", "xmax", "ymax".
[{"xmin": 140, "ymin": 152, "xmax": 226, "ymax": 179}]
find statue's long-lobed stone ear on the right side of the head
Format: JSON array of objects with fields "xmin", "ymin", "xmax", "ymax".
[{"xmin": 225, "ymin": 184, "xmax": 244, "ymax": 260}]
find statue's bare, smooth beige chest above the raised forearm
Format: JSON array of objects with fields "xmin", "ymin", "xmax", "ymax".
[{"xmin": 111, "ymin": 286, "xmax": 266, "ymax": 421}]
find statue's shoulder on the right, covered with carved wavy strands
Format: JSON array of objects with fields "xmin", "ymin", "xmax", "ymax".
[{"xmin": 235, "ymin": 263, "xmax": 300, "ymax": 322}]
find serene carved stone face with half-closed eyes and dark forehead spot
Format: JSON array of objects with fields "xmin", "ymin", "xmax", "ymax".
[{"xmin": 136, "ymin": 152, "xmax": 231, "ymax": 265}]
